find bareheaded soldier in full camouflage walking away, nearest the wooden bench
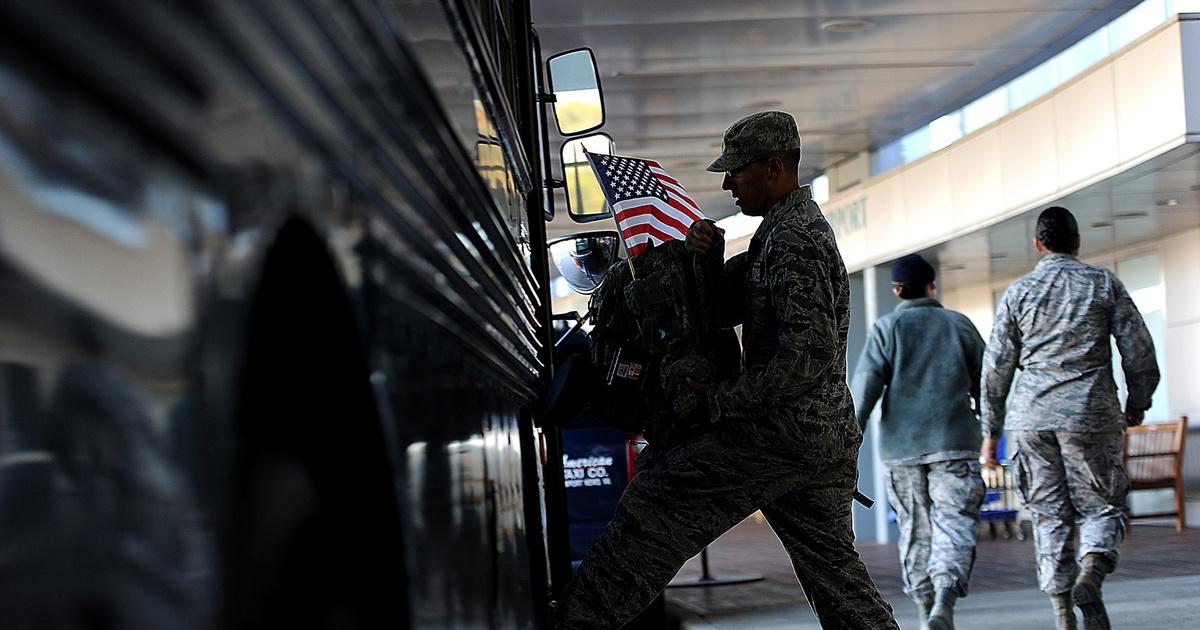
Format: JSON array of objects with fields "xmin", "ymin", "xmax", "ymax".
[{"xmin": 983, "ymin": 206, "xmax": 1159, "ymax": 630}]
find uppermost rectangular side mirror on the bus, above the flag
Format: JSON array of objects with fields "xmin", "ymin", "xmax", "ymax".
[{"xmin": 546, "ymin": 48, "xmax": 605, "ymax": 137}]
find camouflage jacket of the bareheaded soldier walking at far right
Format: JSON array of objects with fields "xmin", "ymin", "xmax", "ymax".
[{"xmin": 982, "ymin": 253, "xmax": 1159, "ymax": 437}]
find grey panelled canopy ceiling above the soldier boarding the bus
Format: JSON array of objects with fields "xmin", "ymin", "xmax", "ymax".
[{"xmin": 533, "ymin": 0, "xmax": 1136, "ymax": 235}]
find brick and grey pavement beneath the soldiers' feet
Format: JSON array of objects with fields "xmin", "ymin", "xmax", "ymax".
[{"xmin": 667, "ymin": 517, "xmax": 1200, "ymax": 630}]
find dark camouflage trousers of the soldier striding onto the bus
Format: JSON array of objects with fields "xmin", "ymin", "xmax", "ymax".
[{"xmin": 558, "ymin": 433, "xmax": 898, "ymax": 630}]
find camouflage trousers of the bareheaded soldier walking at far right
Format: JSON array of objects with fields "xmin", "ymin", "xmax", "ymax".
[{"xmin": 1013, "ymin": 431, "xmax": 1129, "ymax": 594}]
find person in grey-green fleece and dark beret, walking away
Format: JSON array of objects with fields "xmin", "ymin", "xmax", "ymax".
[{"xmin": 851, "ymin": 254, "xmax": 984, "ymax": 630}]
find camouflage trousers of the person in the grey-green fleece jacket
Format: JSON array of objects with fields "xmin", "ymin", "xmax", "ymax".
[{"xmin": 888, "ymin": 460, "xmax": 984, "ymax": 596}]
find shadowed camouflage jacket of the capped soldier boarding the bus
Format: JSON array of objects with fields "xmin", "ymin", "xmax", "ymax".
[{"xmin": 709, "ymin": 187, "xmax": 862, "ymax": 449}]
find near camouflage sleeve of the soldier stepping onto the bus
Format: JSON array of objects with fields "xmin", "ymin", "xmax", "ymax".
[{"xmin": 709, "ymin": 232, "xmax": 841, "ymax": 422}]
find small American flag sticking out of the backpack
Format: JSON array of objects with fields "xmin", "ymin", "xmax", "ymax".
[{"xmin": 587, "ymin": 154, "xmax": 704, "ymax": 256}]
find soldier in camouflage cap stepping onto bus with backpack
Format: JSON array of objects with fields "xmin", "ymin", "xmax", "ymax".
[{"xmin": 556, "ymin": 112, "xmax": 896, "ymax": 630}]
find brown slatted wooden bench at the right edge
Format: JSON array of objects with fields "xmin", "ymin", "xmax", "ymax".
[{"xmin": 1124, "ymin": 415, "xmax": 1188, "ymax": 532}]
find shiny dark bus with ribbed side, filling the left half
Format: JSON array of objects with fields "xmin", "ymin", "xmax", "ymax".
[{"xmin": 0, "ymin": 0, "xmax": 619, "ymax": 630}]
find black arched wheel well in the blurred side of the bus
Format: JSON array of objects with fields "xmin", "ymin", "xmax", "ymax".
[{"xmin": 226, "ymin": 218, "xmax": 407, "ymax": 628}]
